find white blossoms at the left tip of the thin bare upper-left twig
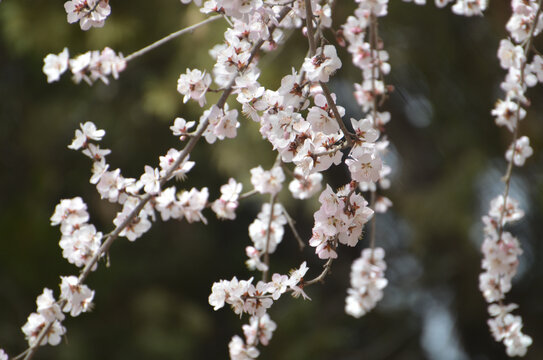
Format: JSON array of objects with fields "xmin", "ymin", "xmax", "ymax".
[{"xmin": 43, "ymin": 47, "xmax": 126, "ymax": 85}]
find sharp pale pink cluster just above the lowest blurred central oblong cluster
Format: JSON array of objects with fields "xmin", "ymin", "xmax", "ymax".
[{"xmin": 309, "ymin": 182, "xmax": 373, "ymax": 259}]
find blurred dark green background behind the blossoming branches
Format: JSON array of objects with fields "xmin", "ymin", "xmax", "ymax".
[{"xmin": 0, "ymin": 0, "xmax": 543, "ymax": 360}]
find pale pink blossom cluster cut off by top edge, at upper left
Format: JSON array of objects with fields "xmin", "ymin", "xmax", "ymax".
[{"xmin": 64, "ymin": 0, "xmax": 111, "ymax": 30}]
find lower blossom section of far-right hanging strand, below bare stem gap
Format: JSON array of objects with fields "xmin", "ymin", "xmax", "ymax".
[{"xmin": 479, "ymin": 195, "xmax": 532, "ymax": 356}]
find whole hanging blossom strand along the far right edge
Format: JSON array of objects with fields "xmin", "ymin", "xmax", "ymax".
[{"xmin": 479, "ymin": 0, "xmax": 543, "ymax": 356}]
